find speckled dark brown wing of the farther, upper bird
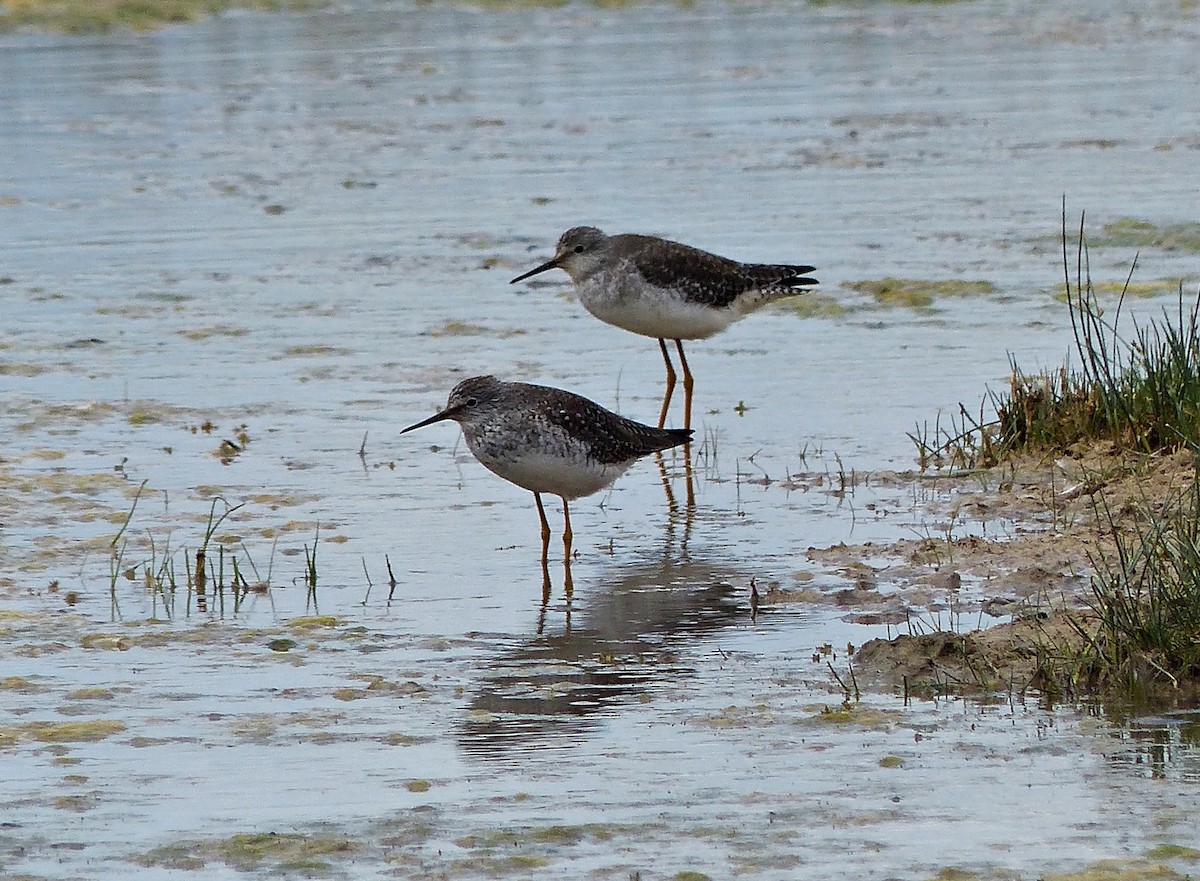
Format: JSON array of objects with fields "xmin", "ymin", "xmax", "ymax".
[{"xmin": 613, "ymin": 235, "xmax": 817, "ymax": 308}]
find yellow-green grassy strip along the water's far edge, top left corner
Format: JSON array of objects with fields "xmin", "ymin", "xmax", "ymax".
[{"xmin": 0, "ymin": 0, "xmax": 318, "ymax": 34}]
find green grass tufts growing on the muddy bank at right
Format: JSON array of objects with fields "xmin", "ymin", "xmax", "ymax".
[{"xmin": 911, "ymin": 214, "xmax": 1200, "ymax": 694}]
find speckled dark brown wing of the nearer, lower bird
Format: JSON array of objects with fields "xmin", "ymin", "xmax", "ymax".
[{"xmin": 530, "ymin": 385, "xmax": 692, "ymax": 465}]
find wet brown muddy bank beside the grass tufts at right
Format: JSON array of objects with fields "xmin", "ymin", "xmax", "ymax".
[{"xmin": 770, "ymin": 444, "xmax": 1195, "ymax": 694}]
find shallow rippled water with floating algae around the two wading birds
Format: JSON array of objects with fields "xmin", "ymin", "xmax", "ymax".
[{"xmin": 0, "ymin": 2, "xmax": 1200, "ymax": 879}]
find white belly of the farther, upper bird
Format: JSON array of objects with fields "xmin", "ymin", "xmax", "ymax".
[{"xmin": 580, "ymin": 283, "xmax": 724, "ymax": 340}]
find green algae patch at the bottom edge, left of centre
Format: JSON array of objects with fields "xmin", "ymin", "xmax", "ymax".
[{"xmin": 136, "ymin": 832, "xmax": 358, "ymax": 873}]
